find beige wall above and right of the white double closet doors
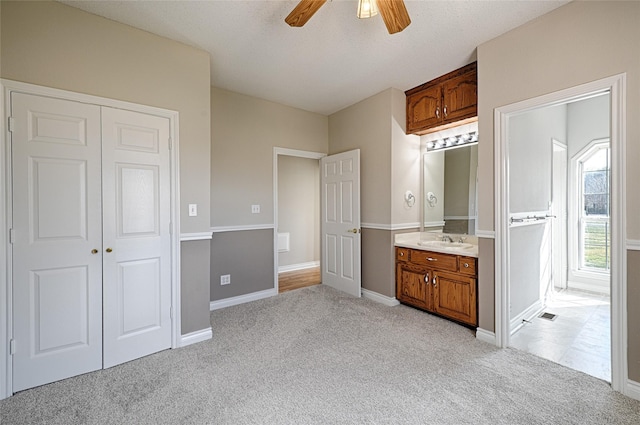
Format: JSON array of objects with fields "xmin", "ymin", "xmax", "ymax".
[{"xmin": 0, "ymin": 1, "xmax": 210, "ymax": 331}]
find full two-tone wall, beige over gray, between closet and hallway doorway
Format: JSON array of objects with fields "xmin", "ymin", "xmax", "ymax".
[{"xmin": 210, "ymin": 87, "xmax": 328, "ymax": 301}]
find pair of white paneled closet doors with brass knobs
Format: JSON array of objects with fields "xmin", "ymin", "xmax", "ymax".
[{"xmin": 11, "ymin": 93, "xmax": 171, "ymax": 392}]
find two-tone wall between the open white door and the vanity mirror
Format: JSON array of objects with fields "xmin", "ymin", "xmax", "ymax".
[{"xmin": 329, "ymin": 89, "xmax": 422, "ymax": 298}]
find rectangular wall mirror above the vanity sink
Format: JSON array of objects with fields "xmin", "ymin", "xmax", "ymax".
[{"xmin": 420, "ymin": 144, "xmax": 478, "ymax": 235}]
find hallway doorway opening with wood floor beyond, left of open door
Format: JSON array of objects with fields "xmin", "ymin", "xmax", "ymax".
[{"xmin": 274, "ymin": 148, "xmax": 325, "ymax": 293}]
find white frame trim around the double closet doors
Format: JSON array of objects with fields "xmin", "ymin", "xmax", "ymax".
[{"xmin": 0, "ymin": 79, "xmax": 181, "ymax": 400}]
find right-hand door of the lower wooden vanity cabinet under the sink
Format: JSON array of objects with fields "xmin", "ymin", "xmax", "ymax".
[{"xmin": 431, "ymin": 272, "xmax": 478, "ymax": 326}]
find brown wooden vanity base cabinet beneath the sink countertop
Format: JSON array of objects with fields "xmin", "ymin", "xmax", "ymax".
[{"xmin": 396, "ymin": 247, "xmax": 478, "ymax": 327}]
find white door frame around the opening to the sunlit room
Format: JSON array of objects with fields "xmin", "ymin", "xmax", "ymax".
[{"xmin": 494, "ymin": 74, "xmax": 632, "ymax": 395}]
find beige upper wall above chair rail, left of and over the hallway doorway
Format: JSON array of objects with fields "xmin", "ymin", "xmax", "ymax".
[{"xmin": 211, "ymin": 87, "xmax": 328, "ymax": 226}]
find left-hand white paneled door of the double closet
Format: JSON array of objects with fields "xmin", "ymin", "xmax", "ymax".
[{"xmin": 11, "ymin": 93, "xmax": 102, "ymax": 391}]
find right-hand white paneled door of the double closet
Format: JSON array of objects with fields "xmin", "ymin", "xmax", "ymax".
[{"xmin": 102, "ymin": 108, "xmax": 171, "ymax": 368}]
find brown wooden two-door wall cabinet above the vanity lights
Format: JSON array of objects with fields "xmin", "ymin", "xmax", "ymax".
[{"xmin": 405, "ymin": 62, "xmax": 478, "ymax": 134}]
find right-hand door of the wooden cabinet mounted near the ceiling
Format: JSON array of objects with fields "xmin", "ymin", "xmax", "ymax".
[{"xmin": 442, "ymin": 70, "xmax": 478, "ymax": 122}]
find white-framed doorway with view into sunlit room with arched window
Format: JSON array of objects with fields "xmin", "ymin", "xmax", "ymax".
[{"xmin": 495, "ymin": 75, "xmax": 627, "ymax": 393}]
